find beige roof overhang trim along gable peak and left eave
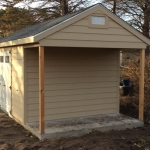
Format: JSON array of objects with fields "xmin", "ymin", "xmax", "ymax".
[{"xmin": 0, "ymin": 4, "xmax": 150, "ymax": 47}]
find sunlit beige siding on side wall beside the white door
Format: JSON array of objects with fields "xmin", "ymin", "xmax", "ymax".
[{"xmin": 11, "ymin": 46, "xmax": 24, "ymax": 122}]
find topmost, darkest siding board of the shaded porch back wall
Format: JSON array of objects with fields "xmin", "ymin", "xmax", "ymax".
[{"xmin": 42, "ymin": 47, "xmax": 117, "ymax": 56}]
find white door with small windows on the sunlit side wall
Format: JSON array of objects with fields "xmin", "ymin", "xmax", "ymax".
[{"xmin": 0, "ymin": 51, "xmax": 11, "ymax": 113}]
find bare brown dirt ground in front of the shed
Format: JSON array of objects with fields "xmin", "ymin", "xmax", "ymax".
[{"xmin": 0, "ymin": 107, "xmax": 150, "ymax": 150}]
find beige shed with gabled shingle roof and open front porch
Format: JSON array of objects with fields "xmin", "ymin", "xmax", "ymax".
[{"xmin": 0, "ymin": 4, "xmax": 150, "ymax": 137}]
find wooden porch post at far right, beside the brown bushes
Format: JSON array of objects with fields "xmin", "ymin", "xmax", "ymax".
[{"xmin": 139, "ymin": 49, "xmax": 145, "ymax": 120}]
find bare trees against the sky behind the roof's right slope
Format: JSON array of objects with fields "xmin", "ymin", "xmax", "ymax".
[{"xmin": 103, "ymin": 0, "xmax": 150, "ymax": 56}]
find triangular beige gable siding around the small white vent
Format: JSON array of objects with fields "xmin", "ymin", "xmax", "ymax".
[{"xmin": 40, "ymin": 12, "xmax": 146, "ymax": 48}]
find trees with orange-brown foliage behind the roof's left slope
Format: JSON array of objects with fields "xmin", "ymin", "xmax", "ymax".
[{"xmin": 0, "ymin": 0, "xmax": 89, "ymax": 37}]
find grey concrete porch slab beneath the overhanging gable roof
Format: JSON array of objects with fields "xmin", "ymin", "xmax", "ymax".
[{"xmin": 28, "ymin": 114, "xmax": 144, "ymax": 139}]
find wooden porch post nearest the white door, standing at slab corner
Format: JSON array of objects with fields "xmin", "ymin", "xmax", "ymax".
[{"xmin": 39, "ymin": 47, "xmax": 45, "ymax": 133}]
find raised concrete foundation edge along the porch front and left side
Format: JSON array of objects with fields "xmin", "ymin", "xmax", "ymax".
[{"xmin": 9, "ymin": 115, "xmax": 144, "ymax": 140}]
